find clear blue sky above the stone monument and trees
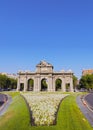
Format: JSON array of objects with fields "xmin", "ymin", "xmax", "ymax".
[{"xmin": 0, "ymin": 0, "xmax": 93, "ymax": 77}]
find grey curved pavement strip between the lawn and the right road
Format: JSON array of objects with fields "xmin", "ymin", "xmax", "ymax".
[{"xmin": 76, "ymin": 93, "xmax": 93, "ymax": 127}]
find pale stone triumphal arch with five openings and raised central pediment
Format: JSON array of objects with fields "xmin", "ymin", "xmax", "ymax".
[{"xmin": 17, "ymin": 61, "xmax": 73, "ymax": 92}]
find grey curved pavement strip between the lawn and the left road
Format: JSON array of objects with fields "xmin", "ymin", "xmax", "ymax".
[{"xmin": 0, "ymin": 95, "xmax": 12, "ymax": 116}]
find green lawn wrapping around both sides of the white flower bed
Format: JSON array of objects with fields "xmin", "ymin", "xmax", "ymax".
[{"xmin": 0, "ymin": 92, "xmax": 93, "ymax": 130}]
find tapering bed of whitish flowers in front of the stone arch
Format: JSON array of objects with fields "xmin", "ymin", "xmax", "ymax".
[{"xmin": 23, "ymin": 93, "xmax": 67, "ymax": 126}]
